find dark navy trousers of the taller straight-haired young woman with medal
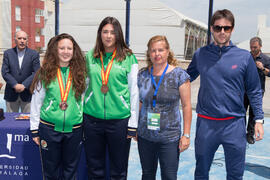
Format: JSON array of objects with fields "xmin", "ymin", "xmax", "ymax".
[{"xmin": 83, "ymin": 114, "xmax": 131, "ymax": 180}]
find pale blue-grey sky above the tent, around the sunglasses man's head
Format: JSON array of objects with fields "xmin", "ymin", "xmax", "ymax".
[{"xmin": 160, "ymin": 0, "xmax": 270, "ymax": 42}]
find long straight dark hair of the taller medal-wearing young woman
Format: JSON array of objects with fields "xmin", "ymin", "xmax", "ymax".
[{"xmin": 94, "ymin": 16, "xmax": 132, "ymax": 61}]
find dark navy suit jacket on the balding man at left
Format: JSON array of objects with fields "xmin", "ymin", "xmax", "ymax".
[{"xmin": 2, "ymin": 47, "xmax": 40, "ymax": 102}]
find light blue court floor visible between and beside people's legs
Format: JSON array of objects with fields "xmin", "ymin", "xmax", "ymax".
[{"xmin": 0, "ymin": 94, "xmax": 270, "ymax": 180}]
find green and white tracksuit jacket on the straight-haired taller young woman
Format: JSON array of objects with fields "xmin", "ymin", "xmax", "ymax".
[{"xmin": 83, "ymin": 50, "xmax": 139, "ymax": 134}]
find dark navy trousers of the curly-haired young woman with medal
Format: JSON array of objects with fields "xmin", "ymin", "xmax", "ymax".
[{"xmin": 39, "ymin": 123, "xmax": 82, "ymax": 180}]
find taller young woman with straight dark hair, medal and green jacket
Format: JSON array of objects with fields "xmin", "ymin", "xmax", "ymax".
[{"xmin": 84, "ymin": 17, "xmax": 139, "ymax": 180}]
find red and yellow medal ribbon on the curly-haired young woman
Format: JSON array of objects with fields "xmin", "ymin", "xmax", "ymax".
[{"xmin": 57, "ymin": 68, "xmax": 72, "ymax": 102}]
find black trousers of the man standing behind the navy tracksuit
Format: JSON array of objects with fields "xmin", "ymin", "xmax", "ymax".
[{"xmin": 244, "ymin": 92, "xmax": 264, "ymax": 135}]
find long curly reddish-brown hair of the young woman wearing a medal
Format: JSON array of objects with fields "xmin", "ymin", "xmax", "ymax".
[{"xmin": 30, "ymin": 33, "xmax": 86, "ymax": 99}]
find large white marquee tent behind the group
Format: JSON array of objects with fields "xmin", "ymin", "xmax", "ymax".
[{"xmin": 44, "ymin": 0, "xmax": 207, "ymax": 58}]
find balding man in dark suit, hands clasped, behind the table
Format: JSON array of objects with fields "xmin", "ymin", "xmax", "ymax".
[{"xmin": 2, "ymin": 31, "xmax": 40, "ymax": 113}]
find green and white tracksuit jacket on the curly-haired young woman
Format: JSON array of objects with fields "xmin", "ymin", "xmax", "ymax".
[{"xmin": 30, "ymin": 68, "xmax": 83, "ymax": 136}]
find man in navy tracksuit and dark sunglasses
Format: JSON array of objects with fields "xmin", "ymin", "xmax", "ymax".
[{"xmin": 187, "ymin": 9, "xmax": 264, "ymax": 180}]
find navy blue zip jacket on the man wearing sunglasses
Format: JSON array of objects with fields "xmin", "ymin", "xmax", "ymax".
[{"xmin": 187, "ymin": 42, "xmax": 263, "ymax": 120}]
